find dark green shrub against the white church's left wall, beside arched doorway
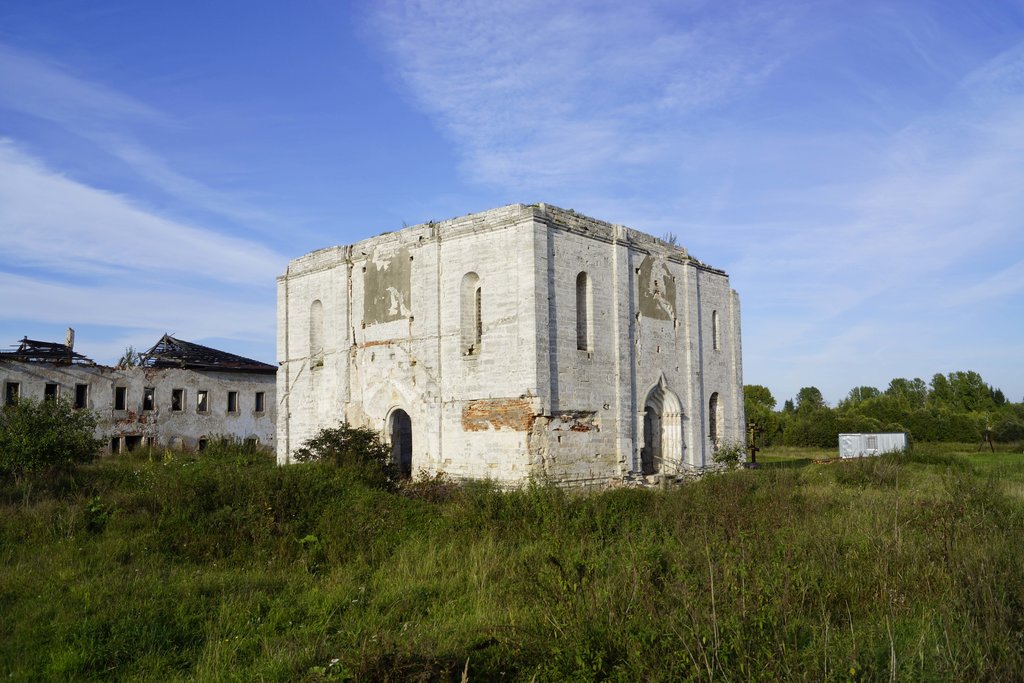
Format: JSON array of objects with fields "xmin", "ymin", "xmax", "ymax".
[{"xmin": 292, "ymin": 423, "xmax": 398, "ymax": 489}]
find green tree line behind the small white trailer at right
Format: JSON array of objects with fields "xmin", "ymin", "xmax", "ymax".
[{"xmin": 743, "ymin": 371, "xmax": 1024, "ymax": 447}]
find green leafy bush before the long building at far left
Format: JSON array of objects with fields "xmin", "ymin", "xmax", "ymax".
[{"xmin": 0, "ymin": 398, "xmax": 102, "ymax": 478}]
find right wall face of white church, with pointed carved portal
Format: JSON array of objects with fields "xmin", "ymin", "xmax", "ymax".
[{"xmin": 530, "ymin": 205, "xmax": 744, "ymax": 483}]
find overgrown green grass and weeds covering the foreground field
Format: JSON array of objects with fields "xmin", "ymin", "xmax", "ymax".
[{"xmin": 0, "ymin": 446, "xmax": 1024, "ymax": 681}]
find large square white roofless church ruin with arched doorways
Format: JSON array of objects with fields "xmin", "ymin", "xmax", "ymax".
[{"xmin": 278, "ymin": 204, "xmax": 744, "ymax": 484}]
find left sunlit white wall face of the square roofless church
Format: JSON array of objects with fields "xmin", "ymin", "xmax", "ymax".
[{"xmin": 278, "ymin": 207, "xmax": 537, "ymax": 480}]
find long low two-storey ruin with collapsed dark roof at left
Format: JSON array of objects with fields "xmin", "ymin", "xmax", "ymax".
[{"xmin": 0, "ymin": 330, "xmax": 278, "ymax": 453}]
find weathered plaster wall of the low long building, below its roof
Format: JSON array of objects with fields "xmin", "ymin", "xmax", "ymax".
[{"xmin": 0, "ymin": 361, "xmax": 276, "ymax": 451}]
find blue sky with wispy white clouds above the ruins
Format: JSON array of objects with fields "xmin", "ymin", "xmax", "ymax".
[{"xmin": 0, "ymin": 0, "xmax": 1024, "ymax": 404}]
